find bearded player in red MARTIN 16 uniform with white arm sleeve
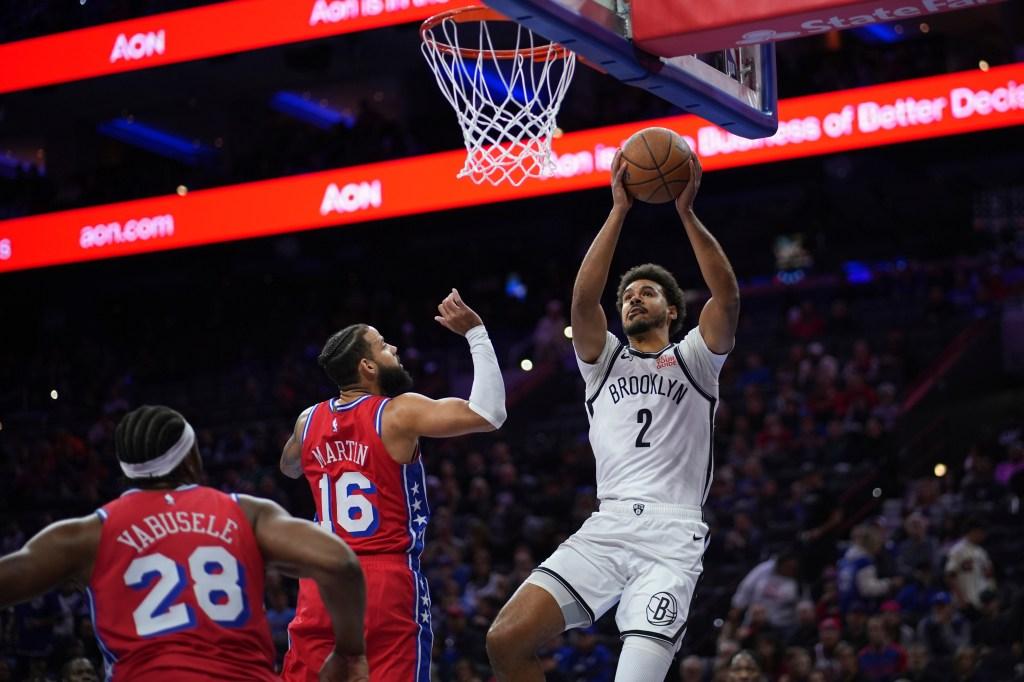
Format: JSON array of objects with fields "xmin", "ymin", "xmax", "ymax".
[{"xmin": 281, "ymin": 289, "xmax": 505, "ymax": 682}]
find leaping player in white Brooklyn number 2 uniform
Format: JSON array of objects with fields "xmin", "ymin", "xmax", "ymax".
[{"xmin": 487, "ymin": 150, "xmax": 739, "ymax": 682}]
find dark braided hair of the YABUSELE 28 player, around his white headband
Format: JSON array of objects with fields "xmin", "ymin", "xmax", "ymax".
[{"xmin": 114, "ymin": 404, "xmax": 193, "ymax": 486}]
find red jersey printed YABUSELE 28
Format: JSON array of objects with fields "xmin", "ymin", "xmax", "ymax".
[{"xmin": 88, "ymin": 485, "xmax": 279, "ymax": 682}]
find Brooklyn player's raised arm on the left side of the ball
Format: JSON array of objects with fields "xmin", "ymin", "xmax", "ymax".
[{"xmin": 569, "ymin": 152, "xmax": 633, "ymax": 363}]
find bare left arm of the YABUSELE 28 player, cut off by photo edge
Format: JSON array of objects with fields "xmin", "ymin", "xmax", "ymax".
[{"xmin": 0, "ymin": 515, "xmax": 102, "ymax": 608}]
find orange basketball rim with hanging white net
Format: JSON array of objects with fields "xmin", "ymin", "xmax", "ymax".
[{"xmin": 420, "ymin": 6, "xmax": 575, "ymax": 185}]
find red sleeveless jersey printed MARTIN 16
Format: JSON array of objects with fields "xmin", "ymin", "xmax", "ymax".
[{"xmin": 302, "ymin": 395, "xmax": 430, "ymax": 557}]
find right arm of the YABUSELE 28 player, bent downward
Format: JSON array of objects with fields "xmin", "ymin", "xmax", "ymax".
[{"xmin": 239, "ymin": 495, "xmax": 369, "ymax": 682}]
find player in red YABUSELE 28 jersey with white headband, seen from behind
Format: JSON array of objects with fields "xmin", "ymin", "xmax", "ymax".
[{"xmin": 0, "ymin": 406, "xmax": 368, "ymax": 682}]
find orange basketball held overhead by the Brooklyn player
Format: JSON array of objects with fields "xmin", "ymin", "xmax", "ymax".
[{"xmin": 623, "ymin": 128, "xmax": 693, "ymax": 204}]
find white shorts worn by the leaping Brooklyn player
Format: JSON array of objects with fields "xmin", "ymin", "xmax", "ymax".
[{"xmin": 526, "ymin": 501, "xmax": 708, "ymax": 650}]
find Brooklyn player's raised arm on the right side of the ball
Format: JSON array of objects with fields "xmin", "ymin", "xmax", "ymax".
[{"xmin": 676, "ymin": 157, "xmax": 739, "ymax": 354}]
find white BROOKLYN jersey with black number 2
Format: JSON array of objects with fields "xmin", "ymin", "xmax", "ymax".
[{"xmin": 577, "ymin": 328, "xmax": 726, "ymax": 507}]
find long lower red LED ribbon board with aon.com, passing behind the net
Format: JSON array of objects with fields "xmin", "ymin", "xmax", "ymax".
[{"xmin": 0, "ymin": 63, "xmax": 1024, "ymax": 272}]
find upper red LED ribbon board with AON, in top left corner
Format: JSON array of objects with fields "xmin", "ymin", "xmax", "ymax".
[{"xmin": 0, "ymin": 0, "xmax": 471, "ymax": 93}]
